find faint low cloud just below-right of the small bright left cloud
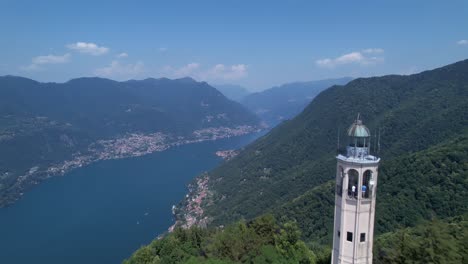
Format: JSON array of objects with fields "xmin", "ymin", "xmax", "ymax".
[{"xmin": 94, "ymin": 60, "xmax": 146, "ymax": 80}]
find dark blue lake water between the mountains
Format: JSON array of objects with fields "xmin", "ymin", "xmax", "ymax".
[{"xmin": 0, "ymin": 134, "xmax": 259, "ymax": 264}]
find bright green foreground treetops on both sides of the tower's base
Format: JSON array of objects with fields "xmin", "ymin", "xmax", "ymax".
[{"xmin": 123, "ymin": 215, "xmax": 468, "ymax": 264}]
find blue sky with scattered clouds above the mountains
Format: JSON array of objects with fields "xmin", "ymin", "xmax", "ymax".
[{"xmin": 0, "ymin": 0, "xmax": 468, "ymax": 91}]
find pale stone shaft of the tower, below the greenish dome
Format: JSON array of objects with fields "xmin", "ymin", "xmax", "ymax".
[{"xmin": 332, "ymin": 156, "xmax": 379, "ymax": 264}]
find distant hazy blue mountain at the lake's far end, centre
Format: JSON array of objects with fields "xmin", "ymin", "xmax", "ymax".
[{"xmin": 240, "ymin": 77, "xmax": 352, "ymax": 126}]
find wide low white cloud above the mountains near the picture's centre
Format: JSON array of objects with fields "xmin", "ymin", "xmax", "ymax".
[{"xmin": 162, "ymin": 62, "xmax": 248, "ymax": 81}]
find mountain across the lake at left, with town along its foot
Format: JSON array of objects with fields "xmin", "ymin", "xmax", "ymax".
[{"xmin": 0, "ymin": 76, "xmax": 259, "ymax": 206}]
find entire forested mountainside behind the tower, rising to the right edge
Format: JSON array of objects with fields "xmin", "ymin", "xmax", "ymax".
[{"xmin": 178, "ymin": 60, "xmax": 468, "ymax": 244}]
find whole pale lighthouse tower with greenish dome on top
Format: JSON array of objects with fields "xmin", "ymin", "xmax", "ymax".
[{"xmin": 332, "ymin": 115, "xmax": 380, "ymax": 264}]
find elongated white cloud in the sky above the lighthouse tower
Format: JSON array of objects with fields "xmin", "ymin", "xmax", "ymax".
[{"xmin": 315, "ymin": 48, "xmax": 384, "ymax": 68}]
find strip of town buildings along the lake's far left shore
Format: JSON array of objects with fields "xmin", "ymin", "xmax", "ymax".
[{"xmin": 0, "ymin": 125, "xmax": 261, "ymax": 207}]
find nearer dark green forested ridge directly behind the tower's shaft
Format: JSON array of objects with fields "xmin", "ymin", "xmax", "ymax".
[{"xmin": 275, "ymin": 133, "xmax": 468, "ymax": 244}]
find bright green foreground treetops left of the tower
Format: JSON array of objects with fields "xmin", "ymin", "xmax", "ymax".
[{"xmin": 124, "ymin": 215, "xmax": 329, "ymax": 264}]
